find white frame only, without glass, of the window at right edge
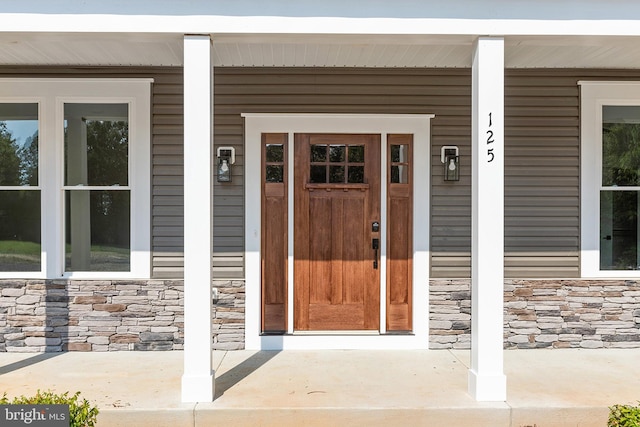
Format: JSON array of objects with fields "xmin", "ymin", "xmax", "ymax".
[{"xmin": 578, "ymin": 81, "xmax": 640, "ymax": 278}]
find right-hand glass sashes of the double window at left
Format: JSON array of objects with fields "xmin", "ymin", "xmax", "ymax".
[{"xmin": 64, "ymin": 104, "xmax": 131, "ymax": 271}]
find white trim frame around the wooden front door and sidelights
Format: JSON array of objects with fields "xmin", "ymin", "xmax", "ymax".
[{"xmin": 242, "ymin": 113, "xmax": 434, "ymax": 350}]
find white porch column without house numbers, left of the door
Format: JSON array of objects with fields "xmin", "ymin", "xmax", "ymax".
[{"xmin": 182, "ymin": 35, "xmax": 214, "ymax": 402}]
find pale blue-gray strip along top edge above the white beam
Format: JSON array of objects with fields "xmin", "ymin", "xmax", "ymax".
[{"xmin": 2, "ymin": 0, "xmax": 640, "ymax": 21}]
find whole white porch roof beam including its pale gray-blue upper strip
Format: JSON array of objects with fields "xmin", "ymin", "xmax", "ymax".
[{"xmin": 6, "ymin": 0, "xmax": 640, "ymax": 36}]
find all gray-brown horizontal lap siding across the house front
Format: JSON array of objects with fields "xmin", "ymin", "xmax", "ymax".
[{"xmin": 0, "ymin": 67, "xmax": 640, "ymax": 279}]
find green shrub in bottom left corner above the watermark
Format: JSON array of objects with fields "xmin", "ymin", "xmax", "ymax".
[{"xmin": 0, "ymin": 390, "xmax": 98, "ymax": 427}]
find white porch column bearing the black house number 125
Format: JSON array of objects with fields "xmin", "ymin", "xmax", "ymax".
[{"xmin": 469, "ymin": 37, "xmax": 507, "ymax": 401}]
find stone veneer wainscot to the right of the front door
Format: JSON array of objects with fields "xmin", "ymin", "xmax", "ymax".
[{"xmin": 429, "ymin": 279, "xmax": 640, "ymax": 349}]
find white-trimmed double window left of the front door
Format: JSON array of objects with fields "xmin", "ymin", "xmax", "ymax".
[{"xmin": 0, "ymin": 79, "xmax": 151, "ymax": 279}]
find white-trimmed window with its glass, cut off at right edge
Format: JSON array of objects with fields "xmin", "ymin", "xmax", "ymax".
[{"xmin": 580, "ymin": 82, "xmax": 640, "ymax": 277}]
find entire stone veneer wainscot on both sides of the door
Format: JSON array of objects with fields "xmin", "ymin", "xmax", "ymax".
[{"xmin": 0, "ymin": 279, "xmax": 640, "ymax": 352}]
